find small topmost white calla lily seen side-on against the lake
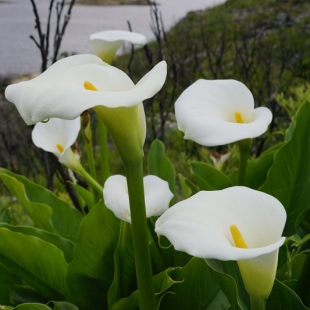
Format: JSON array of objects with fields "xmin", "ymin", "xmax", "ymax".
[{"xmin": 89, "ymin": 30, "xmax": 146, "ymax": 63}]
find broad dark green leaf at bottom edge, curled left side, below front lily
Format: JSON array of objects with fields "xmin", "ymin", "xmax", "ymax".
[{"xmin": 160, "ymin": 258, "xmax": 229, "ymax": 310}]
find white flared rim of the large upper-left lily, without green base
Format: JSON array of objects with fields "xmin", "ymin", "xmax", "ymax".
[{"xmin": 5, "ymin": 54, "xmax": 167, "ymax": 125}]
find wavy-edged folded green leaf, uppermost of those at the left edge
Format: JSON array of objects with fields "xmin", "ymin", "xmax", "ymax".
[{"xmin": 0, "ymin": 168, "xmax": 83, "ymax": 241}]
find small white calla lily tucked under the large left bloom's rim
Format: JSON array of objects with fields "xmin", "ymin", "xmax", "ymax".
[{"xmin": 32, "ymin": 117, "xmax": 81, "ymax": 169}]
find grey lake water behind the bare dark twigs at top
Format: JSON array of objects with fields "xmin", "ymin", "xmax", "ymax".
[{"xmin": 0, "ymin": 0, "xmax": 225, "ymax": 76}]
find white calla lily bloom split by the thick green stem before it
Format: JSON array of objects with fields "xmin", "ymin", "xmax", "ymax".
[{"xmin": 103, "ymin": 175, "xmax": 173, "ymax": 223}]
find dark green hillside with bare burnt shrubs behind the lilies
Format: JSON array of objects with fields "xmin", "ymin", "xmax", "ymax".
[{"xmin": 116, "ymin": 0, "xmax": 310, "ymax": 154}]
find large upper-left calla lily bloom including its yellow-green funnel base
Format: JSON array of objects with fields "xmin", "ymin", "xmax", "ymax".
[{"xmin": 5, "ymin": 55, "xmax": 167, "ymax": 160}]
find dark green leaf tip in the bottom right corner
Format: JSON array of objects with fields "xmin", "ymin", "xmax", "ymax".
[{"xmin": 267, "ymin": 279, "xmax": 309, "ymax": 310}]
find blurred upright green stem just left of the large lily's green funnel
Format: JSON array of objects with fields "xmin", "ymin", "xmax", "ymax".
[{"xmin": 98, "ymin": 117, "xmax": 110, "ymax": 184}]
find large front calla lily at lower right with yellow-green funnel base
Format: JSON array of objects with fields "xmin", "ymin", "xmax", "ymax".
[{"xmin": 155, "ymin": 186, "xmax": 286, "ymax": 299}]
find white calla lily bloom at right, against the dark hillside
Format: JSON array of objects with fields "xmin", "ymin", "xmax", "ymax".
[{"xmin": 175, "ymin": 80, "xmax": 272, "ymax": 146}]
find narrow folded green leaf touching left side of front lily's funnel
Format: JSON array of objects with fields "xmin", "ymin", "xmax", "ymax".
[{"xmin": 205, "ymin": 259, "xmax": 250, "ymax": 310}]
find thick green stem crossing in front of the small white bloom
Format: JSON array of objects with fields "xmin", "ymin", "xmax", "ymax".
[{"xmin": 124, "ymin": 157, "xmax": 155, "ymax": 310}]
